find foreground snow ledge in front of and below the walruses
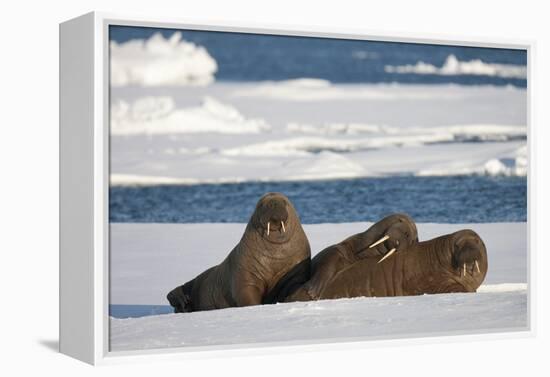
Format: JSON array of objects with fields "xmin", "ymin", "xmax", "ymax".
[{"xmin": 110, "ymin": 290, "xmax": 527, "ymax": 351}]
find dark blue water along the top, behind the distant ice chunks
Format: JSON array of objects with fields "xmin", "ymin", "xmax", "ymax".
[{"xmin": 109, "ymin": 26, "xmax": 527, "ymax": 87}]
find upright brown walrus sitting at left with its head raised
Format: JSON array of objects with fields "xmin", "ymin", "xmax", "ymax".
[{"xmin": 167, "ymin": 193, "xmax": 311, "ymax": 313}]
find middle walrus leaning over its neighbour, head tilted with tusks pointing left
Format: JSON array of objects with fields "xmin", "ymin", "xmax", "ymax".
[{"xmin": 285, "ymin": 213, "xmax": 418, "ymax": 301}]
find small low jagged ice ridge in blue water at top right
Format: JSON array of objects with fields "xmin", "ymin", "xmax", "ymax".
[{"xmin": 384, "ymin": 55, "xmax": 527, "ymax": 79}]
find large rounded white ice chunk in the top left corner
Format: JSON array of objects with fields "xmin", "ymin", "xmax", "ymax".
[{"xmin": 110, "ymin": 32, "xmax": 218, "ymax": 87}]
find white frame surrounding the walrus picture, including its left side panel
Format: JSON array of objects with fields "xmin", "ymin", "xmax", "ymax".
[{"xmin": 59, "ymin": 12, "xmax": 536, "ymax": 364}]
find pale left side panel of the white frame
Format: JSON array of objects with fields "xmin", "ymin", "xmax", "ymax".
[{"xmin": 59, "ymin": 14, "xmax": 96, "ymax": 363}]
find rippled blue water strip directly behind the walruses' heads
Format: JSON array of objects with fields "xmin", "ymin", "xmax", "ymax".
[{"xmin": 109, "ymin": 175, "xmax": 527, "ymax": 224}]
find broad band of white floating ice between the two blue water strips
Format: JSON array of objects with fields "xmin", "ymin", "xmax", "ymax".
[{"xmin": 111, "ymin": 79, "xmax": 528, "ymax": 185}]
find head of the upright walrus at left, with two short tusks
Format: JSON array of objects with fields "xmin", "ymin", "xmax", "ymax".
[{"xmin": 249, "ymin": 192, "xmax": 299, "ymax": 243}]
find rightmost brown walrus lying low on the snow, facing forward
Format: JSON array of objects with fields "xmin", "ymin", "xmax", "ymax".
[{"xmin": 287, "ymin": 225, "xmax": 488, "ymax": 301}]
